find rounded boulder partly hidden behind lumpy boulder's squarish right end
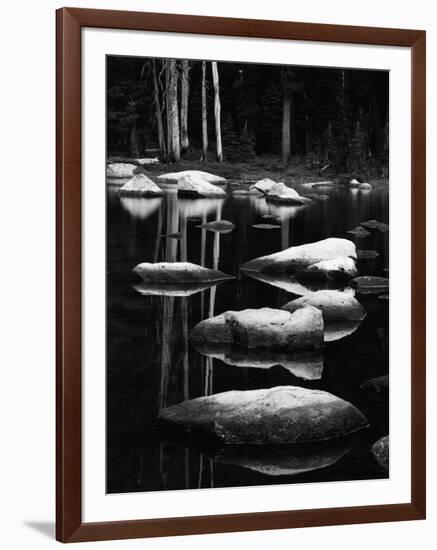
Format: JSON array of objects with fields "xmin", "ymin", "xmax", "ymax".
[{"xmin": 282, "ymin": 290, "xmax": 366, "ymax": 322}]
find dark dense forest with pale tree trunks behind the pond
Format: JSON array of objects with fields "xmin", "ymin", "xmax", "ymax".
[{"xmin": 107, "ymin": 56, "xmax": 389, "ymax": 177}]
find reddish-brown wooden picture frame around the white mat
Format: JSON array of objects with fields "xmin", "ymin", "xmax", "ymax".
[{"xmin": 56, "ymin": 8, "xmax": 426, "ymax": 542}]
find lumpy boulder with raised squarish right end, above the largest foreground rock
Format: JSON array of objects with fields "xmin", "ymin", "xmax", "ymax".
[{"xmin": 191, "ymin": 306, "xmax": 323, "ymax": 350}]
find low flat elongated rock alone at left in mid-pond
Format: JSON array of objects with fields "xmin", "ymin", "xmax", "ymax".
[{"xmin": 133, "ymin": 262, "xmax": 234, "ymax": 285}]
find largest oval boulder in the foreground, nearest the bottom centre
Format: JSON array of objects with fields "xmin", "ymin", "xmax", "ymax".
[{"xmin": 158, "ymin": 386, "xmax": 368, "ymax": 445}]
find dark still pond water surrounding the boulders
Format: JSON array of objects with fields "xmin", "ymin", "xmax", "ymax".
[{"xmin": 107, "ymin": 182, "xmax": 389, "ymax": 493}]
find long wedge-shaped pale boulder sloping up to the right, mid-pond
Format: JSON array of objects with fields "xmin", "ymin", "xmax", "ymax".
[{"xmin": 241, "ymin": 237, "xmax": 357, "ymax": 273}]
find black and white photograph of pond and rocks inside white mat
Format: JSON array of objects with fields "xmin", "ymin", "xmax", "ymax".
[{"xmin": 106, "ymin": 56, "xmax": 390, "ymax": 494}]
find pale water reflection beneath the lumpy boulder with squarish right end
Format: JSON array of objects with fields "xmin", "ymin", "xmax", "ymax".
[{"xmin": 192, "ymin": 342, "xmax": 323, "ymax": 380}]
